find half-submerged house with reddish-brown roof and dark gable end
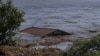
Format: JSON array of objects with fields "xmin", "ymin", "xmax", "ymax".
[{"xmin": 20, "ymin": 27, "xmax": 71, "ymax": 37}]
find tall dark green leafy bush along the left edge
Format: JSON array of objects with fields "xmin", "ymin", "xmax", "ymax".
[{"xmin": 0, "ymin": 0, "xmax": 24, "ymax": 45}]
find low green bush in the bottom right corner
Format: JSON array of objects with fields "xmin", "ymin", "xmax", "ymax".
[{"xmin": 63, "ymin": 35, "xmax": 100, "ymax": 56}]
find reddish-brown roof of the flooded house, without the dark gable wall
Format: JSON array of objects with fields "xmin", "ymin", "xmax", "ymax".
[{"xmin": 20, "ymin": 27, "xmax": 71, "ymax": 36}]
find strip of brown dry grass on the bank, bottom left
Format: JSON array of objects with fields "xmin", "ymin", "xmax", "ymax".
[{"xmin": 0, "ymin": 46, "xmax": 61, "ymax": 56}]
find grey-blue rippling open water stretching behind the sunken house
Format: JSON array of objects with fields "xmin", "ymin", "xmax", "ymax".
[{"xmin": 13, "ymin": 0, "xmax": 100, "ymax": 37}]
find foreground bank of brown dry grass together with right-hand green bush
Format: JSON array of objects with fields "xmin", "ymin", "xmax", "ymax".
[{"xmin": 0, "ymin": 34, "xmax": 100, "ymax": 56}]
